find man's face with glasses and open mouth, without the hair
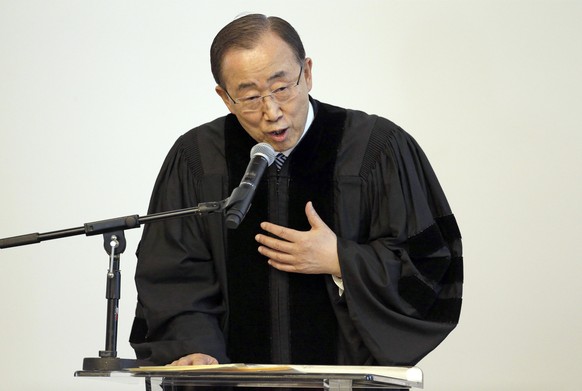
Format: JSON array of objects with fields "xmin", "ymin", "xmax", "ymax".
[{"xmin": 216, "ymin": 33, "xmax": 312, "ymax": 152}]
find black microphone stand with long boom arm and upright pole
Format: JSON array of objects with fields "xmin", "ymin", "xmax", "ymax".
[{"xmin": 0, "ymin": 198, "xmax": 228, "ymax": 371}]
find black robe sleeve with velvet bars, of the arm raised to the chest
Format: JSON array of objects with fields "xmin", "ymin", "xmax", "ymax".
[{"xmin": 338, "ymin": 118, "xmax": 463, "ymax": 365}]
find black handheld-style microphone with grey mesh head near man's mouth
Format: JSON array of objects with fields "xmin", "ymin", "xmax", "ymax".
[{"xmin": 225, "ymin": 143, "xmax": 276, "ymax": 229}]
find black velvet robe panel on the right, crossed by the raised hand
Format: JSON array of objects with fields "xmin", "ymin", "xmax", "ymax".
[{"xmin": 289, "ymin": 105, "xmax": 345, "ymax": 364}]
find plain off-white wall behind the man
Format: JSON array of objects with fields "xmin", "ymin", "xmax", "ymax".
[{"xmin": 0, "ymin": 0, "xmax": 582, "ymax": 391}]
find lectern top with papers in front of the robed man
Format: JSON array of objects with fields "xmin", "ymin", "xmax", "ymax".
[{"xmin": 75, "ymin": 364, "xmax": 423, "ymax": 391}]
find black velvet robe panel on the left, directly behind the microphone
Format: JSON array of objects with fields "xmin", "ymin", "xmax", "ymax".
[{"xmin": 225, "ymin": 115, "xmax": 271, "ymax": 363}]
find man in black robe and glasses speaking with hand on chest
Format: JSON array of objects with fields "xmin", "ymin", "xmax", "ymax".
[{"xmin": 131, "ymin": 15, "xmax": 462, "ymax": 365}]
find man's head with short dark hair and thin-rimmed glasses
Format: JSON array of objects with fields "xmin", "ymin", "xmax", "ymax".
[{"xmin": 210, "ymin": 15, "xmax": 312, "ymax": 151}]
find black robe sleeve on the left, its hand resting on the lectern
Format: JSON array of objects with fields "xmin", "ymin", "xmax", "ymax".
[{"xmin": 130, "ymin": 136, "xmax": 228, "ymax": 365}]
